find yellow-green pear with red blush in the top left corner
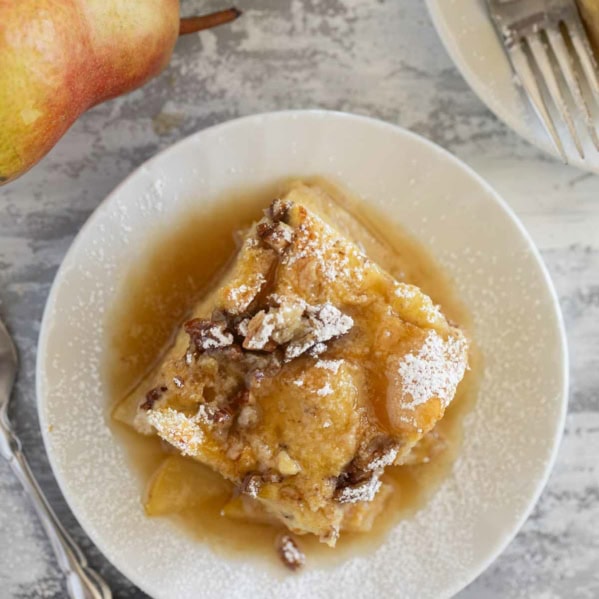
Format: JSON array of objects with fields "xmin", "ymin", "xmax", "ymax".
[{"xmin": 0, "ymin": 0, "xmax": 239, "ymax": 184}]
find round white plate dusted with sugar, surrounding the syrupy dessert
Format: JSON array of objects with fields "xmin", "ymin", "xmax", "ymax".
[{"xmin": 37, "ymin": 111, "xmax": 567, "ymax": 599}]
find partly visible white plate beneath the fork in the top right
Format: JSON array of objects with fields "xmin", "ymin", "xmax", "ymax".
[{"xmin": 426, "ymin": 0, "xmax": 599, "ymax": 172}]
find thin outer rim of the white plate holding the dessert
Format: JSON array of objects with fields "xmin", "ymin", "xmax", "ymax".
[{"xmin": 35, "ymin": 109, "xmax": 569, "ymax": 597}]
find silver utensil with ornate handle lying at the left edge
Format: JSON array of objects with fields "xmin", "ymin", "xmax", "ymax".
[{"xmin": 0, "ymin": 320, "xmax": 112, "ymax": 599}]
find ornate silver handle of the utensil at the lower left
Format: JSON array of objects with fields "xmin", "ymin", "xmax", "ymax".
[{"xmin": 0, "ymin": 427, "xmax": 112, "ymax": 599}]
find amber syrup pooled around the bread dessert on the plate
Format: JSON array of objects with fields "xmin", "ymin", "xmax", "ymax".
[{"xmin": 104, "ymin": 179, "xmax": 481, "ymax": 571}]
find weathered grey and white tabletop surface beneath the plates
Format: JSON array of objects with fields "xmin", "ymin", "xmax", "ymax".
[{"xmin": 0, "ymin": 0, "xmax": 599, "ymax": 599}]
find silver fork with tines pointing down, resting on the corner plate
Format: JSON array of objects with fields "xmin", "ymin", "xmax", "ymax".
[{"xmin": 487, "ymin": 0, "xmax": 599, "ymax": 162}]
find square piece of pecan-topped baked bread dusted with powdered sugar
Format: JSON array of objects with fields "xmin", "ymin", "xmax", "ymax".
[{"xmin": 117, "ymin": 185, "xmax": 468, "ymax": 545}]
